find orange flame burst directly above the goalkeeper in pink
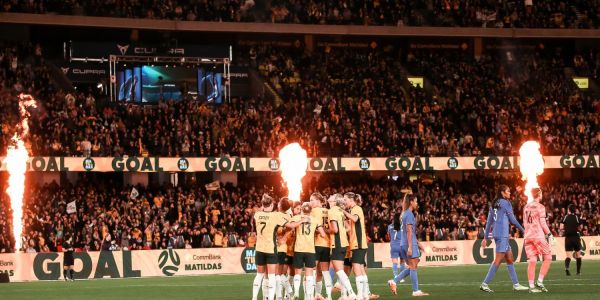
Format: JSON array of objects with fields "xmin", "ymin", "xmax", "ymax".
[{"xmin": 519, "ymin": 141, "xmax": 544, "ymax": 203}]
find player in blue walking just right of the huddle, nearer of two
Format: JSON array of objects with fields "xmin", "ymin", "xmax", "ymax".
[{"xmin": 388, "ymin": 195, "xmax": 429, "ymax": 297}]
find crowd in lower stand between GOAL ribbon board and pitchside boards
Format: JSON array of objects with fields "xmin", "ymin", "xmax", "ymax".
[{"xmin": 0, "ymin": 175, "xmax": 600, "ymax": 252}]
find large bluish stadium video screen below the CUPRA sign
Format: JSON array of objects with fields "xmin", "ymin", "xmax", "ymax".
[{"xmin": 116, "ymin": 66, "xmax": 223, "ymax": 104}]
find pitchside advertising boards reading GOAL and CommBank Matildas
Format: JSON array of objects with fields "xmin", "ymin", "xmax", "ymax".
[{"xmin": 0, "ymin": 236, "xmax": 600, "ymax": 281}]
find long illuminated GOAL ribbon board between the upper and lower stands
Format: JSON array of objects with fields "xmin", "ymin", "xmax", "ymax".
[{"xmin": 0, "ymin": 155, "xmax": 600, "ymax": 172}]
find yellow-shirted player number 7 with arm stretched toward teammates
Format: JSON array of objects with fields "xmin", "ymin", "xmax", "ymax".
[{"xmin": 252, "ymin": 194, "xmax": 310, "ymax": 300}]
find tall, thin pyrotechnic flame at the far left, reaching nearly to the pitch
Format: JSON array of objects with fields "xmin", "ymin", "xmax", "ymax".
[{"xmin": 2, "ymin": 94, "xmax": 36, "ymax": 251}]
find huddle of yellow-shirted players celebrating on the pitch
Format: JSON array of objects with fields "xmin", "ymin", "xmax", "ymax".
[{"xmin": 252, "ymin": 193, "xmax": 378, "ymax": 300}]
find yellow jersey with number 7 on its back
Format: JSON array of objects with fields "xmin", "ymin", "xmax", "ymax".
[{"xmin": 254, "ymin": 211, "xmax": 287, "ymax": 254}]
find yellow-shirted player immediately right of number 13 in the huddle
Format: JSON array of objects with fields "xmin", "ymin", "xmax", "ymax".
[{"xmin": 310, "ymin": 193, "xmax": 332, "ymax": 300}]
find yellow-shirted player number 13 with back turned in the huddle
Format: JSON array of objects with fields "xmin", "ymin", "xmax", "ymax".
[{"xmin": 284, "ymin": 203, "xmax": 319, "ymax": 299}]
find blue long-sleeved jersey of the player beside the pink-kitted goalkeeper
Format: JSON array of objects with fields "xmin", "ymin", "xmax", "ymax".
[{"xmin": 484, "ymin": 198, "xmax": 525, "ymax": 239}]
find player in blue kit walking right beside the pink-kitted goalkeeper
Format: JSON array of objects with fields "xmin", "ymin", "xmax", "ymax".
[{"xmin": 479, "ymin": 185, "xmax": 529, "ymax": 293}]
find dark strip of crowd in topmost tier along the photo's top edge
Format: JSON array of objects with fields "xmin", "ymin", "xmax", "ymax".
[{"xmin": 1, "ymin": 0, "xmax": 600, "ymax": 28}]
